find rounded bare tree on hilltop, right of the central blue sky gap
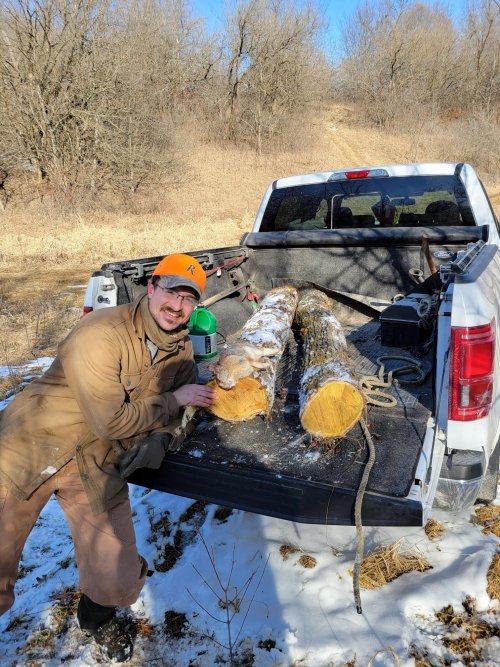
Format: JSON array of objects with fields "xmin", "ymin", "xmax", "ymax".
[{"xmin": 339, "ymin": 0, "xmax": 458, "ymax": 125}]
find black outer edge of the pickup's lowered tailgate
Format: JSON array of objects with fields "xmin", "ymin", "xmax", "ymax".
[{"xmin": 129, "ymin": 454, "xmax": 423, "ymax": 526}]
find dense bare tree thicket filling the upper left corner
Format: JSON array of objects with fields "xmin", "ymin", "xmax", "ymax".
[{"xmin": 0, "ymin": 0, "xmax": 211, "ymax": 198}]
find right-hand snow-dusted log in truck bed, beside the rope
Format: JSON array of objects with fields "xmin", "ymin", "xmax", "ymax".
[{"xmin": 295, "ymin": 290, "xmax": 365, "ymax": 438}]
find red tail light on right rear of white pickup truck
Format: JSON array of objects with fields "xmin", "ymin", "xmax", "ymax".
[{"xmin": 448, "ymin": 319, "xmax": 495, "ymax": 421}]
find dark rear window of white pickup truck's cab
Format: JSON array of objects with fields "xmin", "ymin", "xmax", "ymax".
[{"xmin": 260, "ymin": 176, "xmax": 475, "ymax": 232}]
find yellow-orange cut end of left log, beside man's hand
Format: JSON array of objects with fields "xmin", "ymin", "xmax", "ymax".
[{"xmin": 208, "ymin": 377, "xmax": 268, "ymax": 422}]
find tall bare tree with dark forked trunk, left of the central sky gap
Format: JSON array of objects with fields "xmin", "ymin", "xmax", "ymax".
[{"xmin": 219, "ymin": 0, "xmax": 326, "ymax": 151}]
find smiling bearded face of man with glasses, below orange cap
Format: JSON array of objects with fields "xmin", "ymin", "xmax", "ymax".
[{"xmin": 148, "ymin": 284, "xmax": 198, "ymax": 331}]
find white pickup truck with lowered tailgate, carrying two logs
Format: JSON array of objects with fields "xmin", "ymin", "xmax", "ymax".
[{"xmin": 84, "ymin": 163, "xmax": 500, "ymax": 525}]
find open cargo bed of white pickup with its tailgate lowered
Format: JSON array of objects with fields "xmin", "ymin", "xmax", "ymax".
[{"xmin": 95, "ymin": 190, "xmax": 497, "ymax": 526}]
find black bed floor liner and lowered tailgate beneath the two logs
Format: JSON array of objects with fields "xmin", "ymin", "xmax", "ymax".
[{"xmin": 131, "ymin": 316, "xmax": 432, "ymax": 525}]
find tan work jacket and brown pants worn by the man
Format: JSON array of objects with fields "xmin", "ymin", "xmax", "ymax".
[{"xmin": 0, "ymin": 296, "xmax": 195, "ymax": 614}]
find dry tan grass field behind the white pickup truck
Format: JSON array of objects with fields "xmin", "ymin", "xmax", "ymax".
[{"xmin": 0, "ymin": 105, "xmax": 500, "ymax": 374}]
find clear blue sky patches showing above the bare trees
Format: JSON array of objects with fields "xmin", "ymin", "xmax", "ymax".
[{"xmin": 191, "ymin": 0, "xmax": 467, "ymax": 55}]
